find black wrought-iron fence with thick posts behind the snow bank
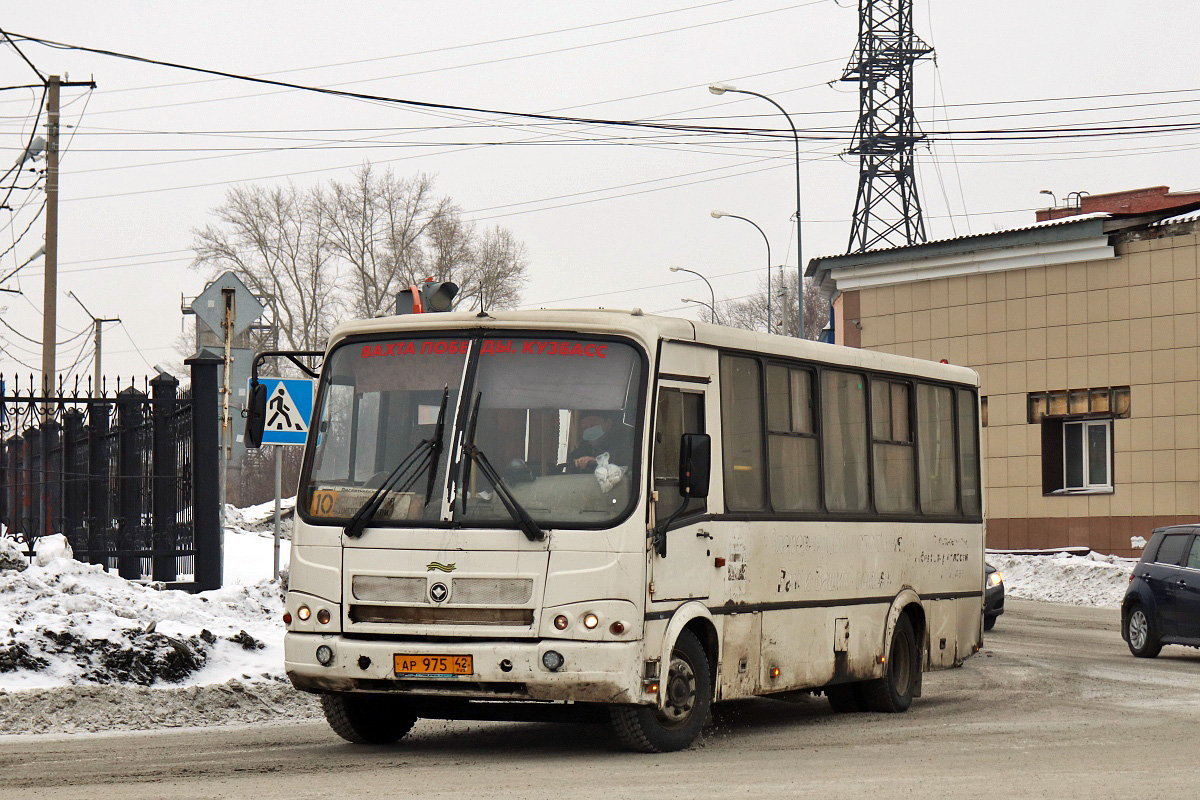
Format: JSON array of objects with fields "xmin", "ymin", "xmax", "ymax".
[{"xmin": 0, "ymin": 353, "xmax": 221, "ymax": 590}]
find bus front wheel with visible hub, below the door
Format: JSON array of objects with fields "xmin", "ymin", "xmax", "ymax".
[{"xmin": 610, "ymin": 631, "xmax": 713, "ymax": 753}]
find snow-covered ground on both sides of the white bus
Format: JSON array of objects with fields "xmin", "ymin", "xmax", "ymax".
[{"xmin": 0, "ymin": 513, "xmax": 1134, "ymax": 735}]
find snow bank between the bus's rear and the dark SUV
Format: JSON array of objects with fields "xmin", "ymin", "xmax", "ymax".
[{"xmin": 988, "ymin": 553, "xmax": 1138, "ymax": 606}]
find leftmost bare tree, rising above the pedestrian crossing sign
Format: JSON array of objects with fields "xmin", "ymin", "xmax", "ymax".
[{"xmin": 192, "ymin": 184, "xmax": 336, "ymax": 350}]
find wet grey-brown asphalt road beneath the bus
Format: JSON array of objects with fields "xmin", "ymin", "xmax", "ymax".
[{"xmin": 0, "ymin": 600, "xmax": 1200, "ymax": 800}]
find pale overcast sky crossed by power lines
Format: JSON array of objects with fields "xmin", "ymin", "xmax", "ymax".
[{"xmin": 0, "ymin": 0, "xmax": 1200, "ymax": 383}]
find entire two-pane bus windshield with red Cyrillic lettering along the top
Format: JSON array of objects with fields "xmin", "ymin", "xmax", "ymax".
[{"xmin": 301, "ymin": 335, "xmax": 646, "ymax": 528}]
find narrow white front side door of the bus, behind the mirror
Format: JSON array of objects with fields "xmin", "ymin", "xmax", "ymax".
[{"xmin": 650, "ymin": 380, "xmax": 718, "ymax": 601}]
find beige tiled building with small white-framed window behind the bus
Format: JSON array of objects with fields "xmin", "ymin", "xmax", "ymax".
[{"xmin": 808, "ymin": 187, "xmax": 1200, "ymax": 555}]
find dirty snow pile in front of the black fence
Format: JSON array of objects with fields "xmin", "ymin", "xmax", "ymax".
[{"xmin": 0, "ymin": 537, "xmax": 283, "ymax": 688}]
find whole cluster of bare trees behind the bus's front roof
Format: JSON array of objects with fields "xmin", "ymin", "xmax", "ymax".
[{"xmin": 193, "ymin": 163, "xmax": 528, "ymax": 349}]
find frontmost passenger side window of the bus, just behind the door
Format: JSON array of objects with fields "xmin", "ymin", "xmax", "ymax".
[{"xmin": 721, "ymin": 355, "xmax": 767, "ymax": 511}]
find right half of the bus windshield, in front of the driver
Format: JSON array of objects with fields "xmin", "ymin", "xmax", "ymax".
[{"xmin": 456, "ymin": 338, "xmax": 643, "ymax": 528}]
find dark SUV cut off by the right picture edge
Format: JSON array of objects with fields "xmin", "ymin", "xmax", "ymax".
[{"xmin": 1121, "ymin": 524, "xmax": 1200, "ymax": 658}]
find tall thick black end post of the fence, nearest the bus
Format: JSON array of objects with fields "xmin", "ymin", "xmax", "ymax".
[{"xmin": 184, "ymin": 349, "xmax": 224, "ymax": 591}]
